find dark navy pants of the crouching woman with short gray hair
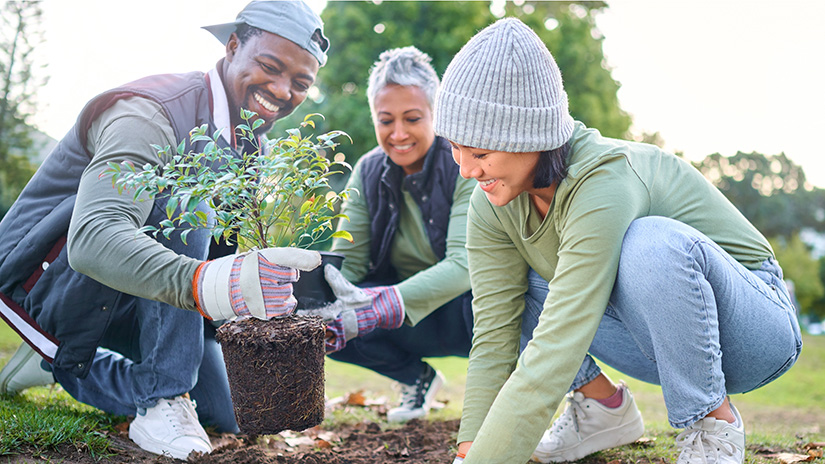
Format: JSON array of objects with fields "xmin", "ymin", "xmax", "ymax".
[{"xmin": 329, "ymin": 292, "xmax": 473, "ymax": 385}]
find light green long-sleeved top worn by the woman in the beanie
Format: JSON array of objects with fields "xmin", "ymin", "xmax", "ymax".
[{"xmin": 458, "ymin": 122, "xmax": 773, "ymax": 464}]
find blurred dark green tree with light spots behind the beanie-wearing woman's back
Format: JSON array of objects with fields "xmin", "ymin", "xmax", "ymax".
[{"xmin": 694, "ymin": 152, "xmax": 825, "ymax": 240}]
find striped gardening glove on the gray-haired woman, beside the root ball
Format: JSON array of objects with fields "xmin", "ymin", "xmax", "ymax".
[{"xmin": 299, "ymin": 264, "xmax": 404, "ymax": 353}]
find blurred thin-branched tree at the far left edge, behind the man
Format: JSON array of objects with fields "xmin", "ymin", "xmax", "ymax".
[{"xmin": 0, "ymin": 1, "xmax": 48, "ymax": 217}]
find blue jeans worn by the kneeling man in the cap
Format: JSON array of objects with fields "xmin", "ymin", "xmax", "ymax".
[{"xmin": 53, "ymin": 298, "xmax": 238, "ymax": 433}]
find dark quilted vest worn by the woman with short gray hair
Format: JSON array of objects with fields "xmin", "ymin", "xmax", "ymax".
[{"xmin": 360, "ymin": 137, "xmax": 458, "ymax": 282}]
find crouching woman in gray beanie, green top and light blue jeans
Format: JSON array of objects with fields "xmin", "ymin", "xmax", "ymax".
[{"xmin": 435, "ymin": 18, "xmax": 802, "ymax": 464}]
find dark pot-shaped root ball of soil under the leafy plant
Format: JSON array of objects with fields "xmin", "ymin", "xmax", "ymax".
[{"xmin": 216, "ymin": 315, "xmax": 326, "ymax": 436}]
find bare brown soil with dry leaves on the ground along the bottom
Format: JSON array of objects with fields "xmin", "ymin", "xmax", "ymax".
[{"xmin": 0, "ymin": 420, "xmax": 825, "ymax": 464}]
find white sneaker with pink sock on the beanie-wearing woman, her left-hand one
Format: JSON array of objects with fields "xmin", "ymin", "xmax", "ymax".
[{"xmin": 532, "ymin": 383, "xmax": 645, "ymax": 463}]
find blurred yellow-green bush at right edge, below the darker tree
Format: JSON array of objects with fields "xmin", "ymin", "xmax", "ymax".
[{"xmin": 770, "ymin": 235, "xmax": 825, "ymax": 313}]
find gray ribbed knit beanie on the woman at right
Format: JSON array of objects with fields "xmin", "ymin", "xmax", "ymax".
[{"xmin": 435, "ymin": 18, "xmax": 573, "ymax": 152}]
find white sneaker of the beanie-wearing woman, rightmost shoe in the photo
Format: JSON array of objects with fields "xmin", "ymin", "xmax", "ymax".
[{"xmin": 676, "ymin": 403, "xmax": 745, "ymax": 464}]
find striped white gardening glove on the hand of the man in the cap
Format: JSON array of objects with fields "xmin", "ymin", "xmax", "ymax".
[{"xmin": 192, "ymin": 248, "xmax": 321, "ymax": 320}]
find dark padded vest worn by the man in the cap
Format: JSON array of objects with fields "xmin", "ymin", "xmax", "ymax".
[{"xmin": 0, "ymin": 72, "xmax": 230, "ymax": 377}]
